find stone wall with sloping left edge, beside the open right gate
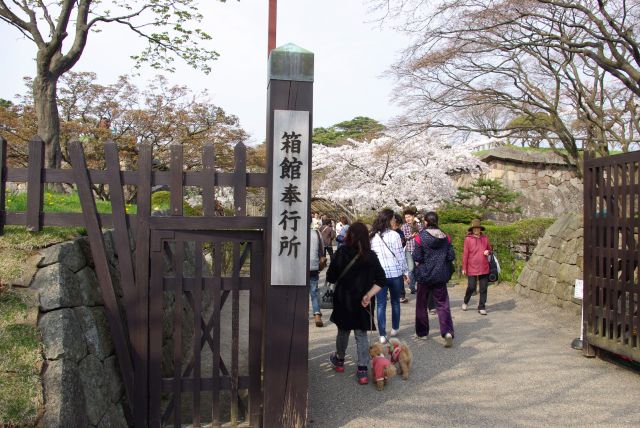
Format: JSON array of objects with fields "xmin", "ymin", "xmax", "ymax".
[{"xmin": 516, "ymin": 214, "xmax": 583, "ymax": 313}]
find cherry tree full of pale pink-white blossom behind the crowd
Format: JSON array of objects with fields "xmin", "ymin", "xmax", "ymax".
[{"xmin": 313, "ymin": 133, "xmax": 486, "ymax": 214}]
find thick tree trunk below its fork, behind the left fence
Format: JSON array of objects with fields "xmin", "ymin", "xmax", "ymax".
[{"xmin": 33, "ymin": 76, "xmax": 62, "ymax": 168}]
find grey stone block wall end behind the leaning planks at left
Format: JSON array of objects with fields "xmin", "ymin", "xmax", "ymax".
[{"xmin": 30, "ymin": 232, "xmax": 127, "ymax": 427}]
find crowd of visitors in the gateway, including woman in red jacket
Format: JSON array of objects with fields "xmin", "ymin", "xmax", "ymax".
[{"xmin": 310, "ymin": 207, "xmax": 492, "ymax": 384}]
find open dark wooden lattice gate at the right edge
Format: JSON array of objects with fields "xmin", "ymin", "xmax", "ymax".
[{"xmin": 583, "ymin": 152, "xmax": 640, "ymax": 361}]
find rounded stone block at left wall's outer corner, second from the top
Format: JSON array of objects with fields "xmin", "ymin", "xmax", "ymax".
[{"xmin": 31, "ymin": 263, "xmax": 82, "ymax": 312}]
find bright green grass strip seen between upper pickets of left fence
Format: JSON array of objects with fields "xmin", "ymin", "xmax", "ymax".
[{"xmin": 7, "ymin": 190, "xmax": 136, "ymax": 214}]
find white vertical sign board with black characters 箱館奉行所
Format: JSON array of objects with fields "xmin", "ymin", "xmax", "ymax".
[{"xmin": 271, "ymin": 110, "xmax": 311, "ymax": 286}]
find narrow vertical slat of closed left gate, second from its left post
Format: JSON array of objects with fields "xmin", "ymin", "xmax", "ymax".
[{"xmin": 192, "ymin": 242, "xmax": 203, "ymax": 427}]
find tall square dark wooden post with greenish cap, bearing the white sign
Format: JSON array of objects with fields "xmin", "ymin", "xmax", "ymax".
[{"xmin": 263, "ymin": 44, "xmax": 313, "ymax": 428}]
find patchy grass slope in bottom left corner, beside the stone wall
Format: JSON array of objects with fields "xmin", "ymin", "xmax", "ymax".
[{"xmin": 0, "ymin": 288, "xmax": 42, "ymax": 427}]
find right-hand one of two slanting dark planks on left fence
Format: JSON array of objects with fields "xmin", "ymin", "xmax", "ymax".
[{"xmin": 104, "ymin": 141, "xmax": 136, "ymax": 346}]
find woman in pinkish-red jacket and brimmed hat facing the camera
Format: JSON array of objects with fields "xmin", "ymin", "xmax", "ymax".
[{"xmin": 462, "ymin": 219, "xmax": 492, "ymax": 315}]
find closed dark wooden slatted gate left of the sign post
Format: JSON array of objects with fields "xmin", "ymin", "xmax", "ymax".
[{"xmin": 149, "ymin": 229, "xmax": 264, "ymax": 427}]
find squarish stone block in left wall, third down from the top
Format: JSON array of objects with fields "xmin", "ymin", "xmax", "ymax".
[{"xmin": 38, "ymin": 309, "xmax": 87, "ymax": 362}]
